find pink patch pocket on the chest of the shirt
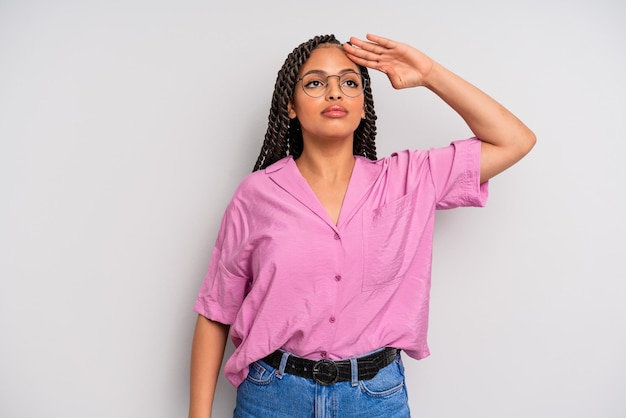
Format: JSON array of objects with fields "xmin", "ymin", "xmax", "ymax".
[{"xmin": 362, "ymin": 193, "xmax": 419, "ymax": 291}]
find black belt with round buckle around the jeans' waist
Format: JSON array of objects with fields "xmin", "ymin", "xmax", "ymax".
[{"xmin": 263, "ymin": 348, "xmax": 399, "ymax": 385}]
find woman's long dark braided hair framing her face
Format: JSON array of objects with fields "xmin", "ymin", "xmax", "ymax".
[{"xmin": 252, "ymin": 35, "xmax": 376, "ymax": 171}]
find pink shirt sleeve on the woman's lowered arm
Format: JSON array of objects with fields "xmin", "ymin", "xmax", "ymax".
[{"xmin": 194, "ymin": 202, "xmax": 249, "ymax": 324}]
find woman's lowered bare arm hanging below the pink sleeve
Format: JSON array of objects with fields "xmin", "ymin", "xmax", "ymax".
[{"xmin": 189, "ymin": 315, "xmax": 228, "ymax": 418}]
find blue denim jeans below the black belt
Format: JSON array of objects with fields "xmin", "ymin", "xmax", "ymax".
[{"xmin": 233, "ymin": 353, "xmax": 411, "ymax": 418}]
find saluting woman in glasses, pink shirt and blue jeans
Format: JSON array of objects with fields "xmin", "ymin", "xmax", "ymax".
[{"xmin": 189, "ymin": 35, "xmax": 535, "ymax": 418}]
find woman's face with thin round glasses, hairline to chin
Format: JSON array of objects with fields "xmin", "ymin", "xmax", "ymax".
[{"xmin": 288, "ymin": 45, "xmax": 365, "ymax": 143}]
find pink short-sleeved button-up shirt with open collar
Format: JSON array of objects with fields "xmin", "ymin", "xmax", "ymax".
[{"xmin": 194, "ymin": 139, "xmax": 488, "ymax": 386}]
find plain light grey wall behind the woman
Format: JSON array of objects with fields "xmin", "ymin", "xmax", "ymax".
[{"xmin": 0, "ymin": 0, "xmax": 626, "ymax": 418}]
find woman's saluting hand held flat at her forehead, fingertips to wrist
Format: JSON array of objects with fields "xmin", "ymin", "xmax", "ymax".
[{"xmin": 343, "ymin": 34, "xmax": 435, "ymax": 89}]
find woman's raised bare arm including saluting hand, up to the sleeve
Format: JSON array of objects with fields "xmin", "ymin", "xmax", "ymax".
[{"xmin": 343, "ymin": 34, "xmax": 536, "ymax": 182}]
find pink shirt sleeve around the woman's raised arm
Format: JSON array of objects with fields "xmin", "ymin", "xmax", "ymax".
[{"xmin": 428, "ymin": 138, "xmax": 489, "ymax": 209}]
